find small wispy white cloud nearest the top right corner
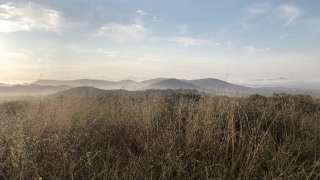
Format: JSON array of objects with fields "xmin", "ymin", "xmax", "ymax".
[{"xmin": 278, "ymin": 5, "xmax": 302, "ymax": 25}]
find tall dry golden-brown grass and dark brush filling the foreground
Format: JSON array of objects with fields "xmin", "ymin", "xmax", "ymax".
[{"xmin": 0, "ymin": 92, "xmax": 320, "ymax": 179}]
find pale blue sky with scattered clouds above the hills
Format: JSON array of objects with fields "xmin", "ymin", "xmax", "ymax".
[{"xmin": 0, "ymin": 0, "xmax": 320, "ymax": 83}]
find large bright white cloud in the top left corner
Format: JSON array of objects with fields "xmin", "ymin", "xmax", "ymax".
[{"xmin": 0, "ymin": 2, "xmax": 64, "ymax": 33}]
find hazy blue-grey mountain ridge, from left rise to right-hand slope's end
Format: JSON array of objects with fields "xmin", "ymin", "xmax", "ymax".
[{"xmin": 31, "ymin": 78, "xmax": 254, "ymax": 94}]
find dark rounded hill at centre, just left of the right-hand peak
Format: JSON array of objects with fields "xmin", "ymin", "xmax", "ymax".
[{"xmin": 144, "ymin": 79, "xmax": 201, "ymax": 90}]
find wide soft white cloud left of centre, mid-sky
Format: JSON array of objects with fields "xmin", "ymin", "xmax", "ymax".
[{"xmin": 96, "ymin": 23, "xmax": 148, "ymax": 42}]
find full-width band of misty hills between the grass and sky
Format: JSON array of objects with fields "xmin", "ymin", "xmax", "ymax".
[{"xmin": 0, "ymin": 78, "xmax": 320, "ymax": 96}]
